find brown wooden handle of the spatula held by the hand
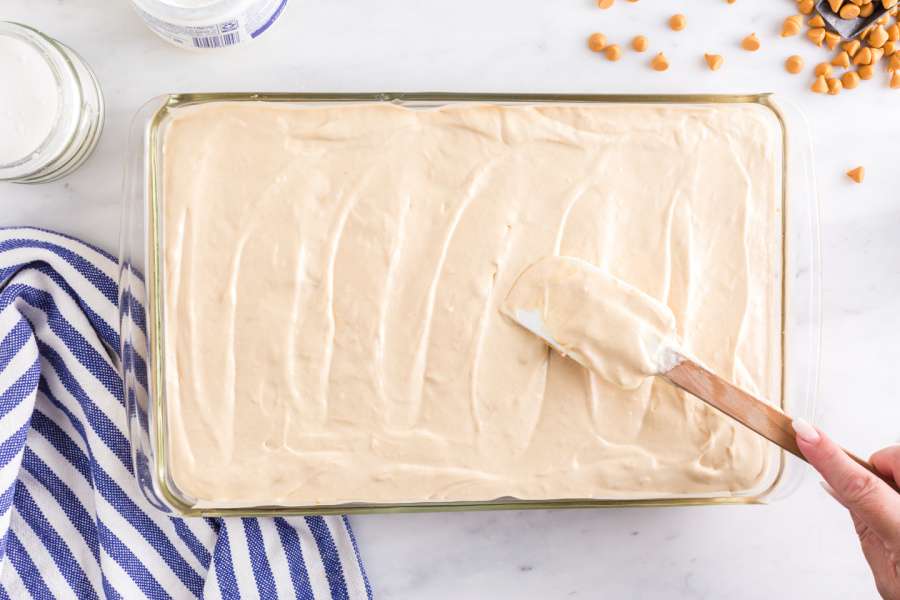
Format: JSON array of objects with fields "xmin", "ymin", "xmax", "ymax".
[{"xmin": 663, "ymin": 359, "xmax": 900, "ymax": 491}]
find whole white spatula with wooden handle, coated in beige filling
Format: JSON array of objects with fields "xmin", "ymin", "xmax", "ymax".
[{"xmin": 502, "ymin": 257, "xmax": 897, "ymax": 489}]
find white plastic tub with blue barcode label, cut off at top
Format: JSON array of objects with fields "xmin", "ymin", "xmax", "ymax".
[{"xmin": 132, "ymin": 0, "xmax": 287, "ymax": 50}]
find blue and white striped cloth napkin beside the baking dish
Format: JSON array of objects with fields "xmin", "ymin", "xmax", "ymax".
[{"xmin": 0, "ymin": 228, "xmax": 372, "ymax": 600}]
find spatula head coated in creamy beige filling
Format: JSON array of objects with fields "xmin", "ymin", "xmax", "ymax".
[{"xmin": 501, "ymin": 256, "xmax": 679, "ymax": 390}]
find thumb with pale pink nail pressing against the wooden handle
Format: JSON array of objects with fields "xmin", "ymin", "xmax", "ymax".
[{"xmin": 793, "ymin": 419, "xmax": 900, "ymax": 543}]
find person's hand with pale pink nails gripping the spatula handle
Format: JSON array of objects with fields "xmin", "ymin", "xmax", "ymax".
[{"xmin": 794, "ymin": 419, "xmax": 900, "ymax": 600}]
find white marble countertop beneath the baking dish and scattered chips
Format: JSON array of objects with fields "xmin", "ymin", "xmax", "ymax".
[{"xmin": 0, "ymin": 0, "xmax": 900, "ymax": 600}]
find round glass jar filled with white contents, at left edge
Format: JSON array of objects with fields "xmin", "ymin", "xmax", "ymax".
[{"xmin": 0, "ymin": 21, "xmax": 104, "ymax": 183}]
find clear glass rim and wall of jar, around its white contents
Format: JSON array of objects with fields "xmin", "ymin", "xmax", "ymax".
[{"xmin": 0, "ymin": 21, "xmax": 105, "ymax": 183}]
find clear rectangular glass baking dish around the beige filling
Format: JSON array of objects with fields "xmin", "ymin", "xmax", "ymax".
[{"xmin": 119, "ymin": 93, "xmax": 821, "ymax": 516}]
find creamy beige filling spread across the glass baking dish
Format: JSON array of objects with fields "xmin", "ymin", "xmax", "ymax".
[{"xmin": 162, "ymin": 102, "xmax": 782, "ymax": 506}]
